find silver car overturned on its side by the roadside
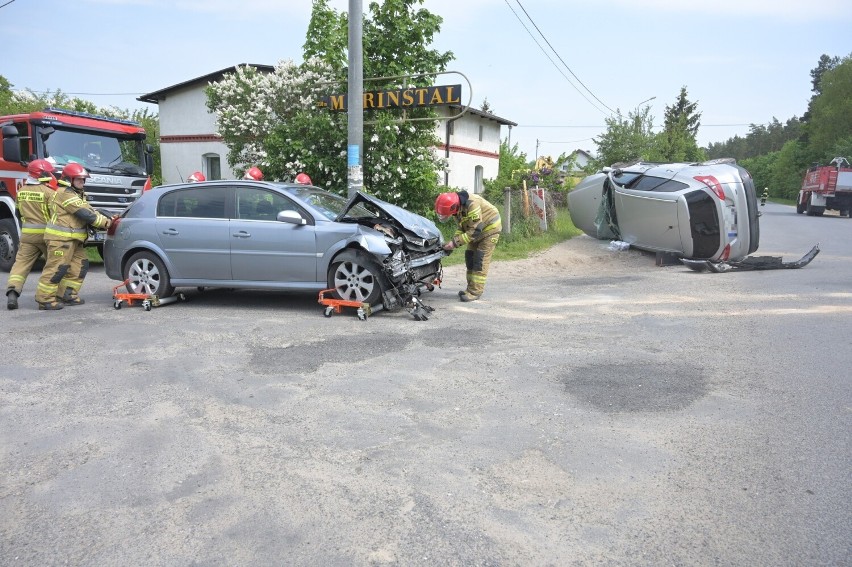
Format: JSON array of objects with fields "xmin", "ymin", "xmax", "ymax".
[{"xmin": 568, "ymin": 159, "xmax": 760, "ymax": 262}]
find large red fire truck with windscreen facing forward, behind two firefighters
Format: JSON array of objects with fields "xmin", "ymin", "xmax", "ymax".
[{"xmin": 0, "ymin": 108, "xmax": 154, "ymax": 271}]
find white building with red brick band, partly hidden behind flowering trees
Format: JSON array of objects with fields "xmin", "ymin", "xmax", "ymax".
[{"xmin": 137, "ymin": 63, "xmax": 517, "ymax": 193}]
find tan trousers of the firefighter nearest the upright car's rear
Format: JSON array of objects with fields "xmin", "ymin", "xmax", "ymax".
[{"xmin": 36, "ymin": 240, "xmax": 89, "ymax": 303}]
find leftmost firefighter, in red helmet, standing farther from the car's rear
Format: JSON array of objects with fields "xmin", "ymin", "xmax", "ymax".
[{"xmin": 6, "ymin": 159, "xmax": 56, "ymax": 309}]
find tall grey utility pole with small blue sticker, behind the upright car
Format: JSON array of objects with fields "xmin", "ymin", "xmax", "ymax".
[{"xmin": 346, "ymin": 0, "xmax": 364, "ymax": 199}]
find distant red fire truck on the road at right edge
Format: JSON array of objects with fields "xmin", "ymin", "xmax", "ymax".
[{"xmin": 796, "ymin": 157, "xmax": 852, "ymax": 217}]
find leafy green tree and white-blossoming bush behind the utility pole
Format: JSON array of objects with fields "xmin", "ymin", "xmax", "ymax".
[{"xmin": 207, "ymin": 0, "xmax": 452, "ymax": 212}]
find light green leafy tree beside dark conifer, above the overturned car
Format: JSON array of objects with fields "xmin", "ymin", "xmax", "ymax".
[{"xmin": 590, "ymin": 106, "xmax": 654, "ymax": 169}]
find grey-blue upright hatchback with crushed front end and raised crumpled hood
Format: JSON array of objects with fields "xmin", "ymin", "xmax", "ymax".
[{"xmin": 103, "ymin": 180, "xmax": 444, "ymax": 310}]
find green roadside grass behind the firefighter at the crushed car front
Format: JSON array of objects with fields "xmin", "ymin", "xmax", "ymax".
[{"xmin": 440, "ymin": 208, "xmax": 582, "ymax": 266}]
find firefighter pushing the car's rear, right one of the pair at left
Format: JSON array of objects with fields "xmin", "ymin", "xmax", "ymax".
[{"xmin": 36, "ymin": 163, "xmax": 112, "ymax": 311}]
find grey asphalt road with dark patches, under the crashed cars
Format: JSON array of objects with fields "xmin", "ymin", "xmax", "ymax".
[{"xmin": 0, "ymin": 204, "xmax": 852, "ymax": 566}]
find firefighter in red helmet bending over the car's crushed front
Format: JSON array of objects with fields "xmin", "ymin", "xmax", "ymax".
[{"xmin": 435, "ymin": 191, "xmax": 503, "ymax": 301}]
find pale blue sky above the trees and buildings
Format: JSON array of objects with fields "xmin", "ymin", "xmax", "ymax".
[{"xmin": 0, "ymin": 0, "xmax": 852, "ymax": 159}]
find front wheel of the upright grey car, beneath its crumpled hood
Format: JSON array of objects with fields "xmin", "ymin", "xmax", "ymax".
[{"xmin": 328, "ymin": 250, "xmax": 386, "ymax": 305}]
